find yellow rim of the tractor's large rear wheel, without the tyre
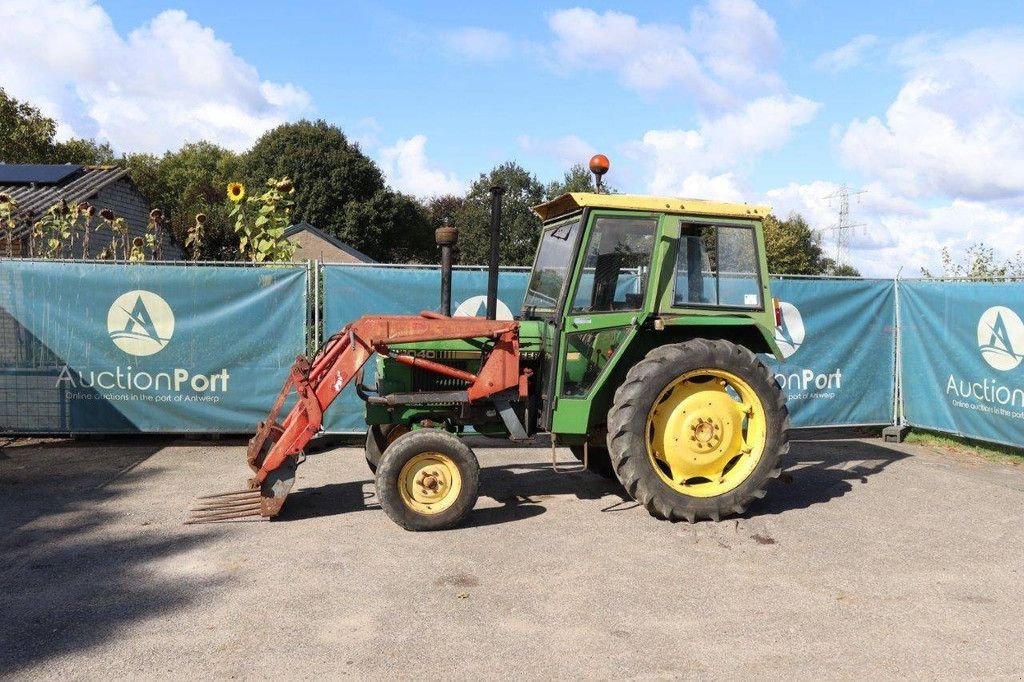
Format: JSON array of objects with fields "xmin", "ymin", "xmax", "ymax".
[{"xmin": 645, "ymin": 369, "xmax": 767, "ymax": 498}]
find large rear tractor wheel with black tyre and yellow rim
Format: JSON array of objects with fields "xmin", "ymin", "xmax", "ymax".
[{"xmin": 608, "ymin": 339, "xmax": 790, "ymax": 522}]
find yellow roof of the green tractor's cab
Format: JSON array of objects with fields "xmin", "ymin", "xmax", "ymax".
[{"xmin": 534, "ymin": 191, "xmax": 771, "ymax": 220}]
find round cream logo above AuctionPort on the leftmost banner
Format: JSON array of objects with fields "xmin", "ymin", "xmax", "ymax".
[{"xmin": 106, "ymin": 289, "xmax": 174, "ymax": 355}]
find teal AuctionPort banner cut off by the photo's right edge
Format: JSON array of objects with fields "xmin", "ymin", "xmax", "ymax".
[{"xmin": 899, "ymin": 281, "xmax": 1024, "ymax": 447}]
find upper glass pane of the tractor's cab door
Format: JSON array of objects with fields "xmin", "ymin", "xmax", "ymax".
[{"xmin": 571, "ymin": 216, "xmax": 657, "ymax": 312}]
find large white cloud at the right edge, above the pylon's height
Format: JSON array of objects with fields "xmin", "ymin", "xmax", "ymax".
[{"xmin": 841, "ymin": 31, "xmax": 1024, "ymax": 200}]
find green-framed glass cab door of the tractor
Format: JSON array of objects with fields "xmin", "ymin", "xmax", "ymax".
[{"xmin": 551, "ymin": 211, "xmax": 660, "ymax": 433}]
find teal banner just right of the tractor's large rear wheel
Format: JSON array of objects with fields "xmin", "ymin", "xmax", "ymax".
[{"xmin": 769, "ymin": 280, "xmax": 895, "ymax": 427}]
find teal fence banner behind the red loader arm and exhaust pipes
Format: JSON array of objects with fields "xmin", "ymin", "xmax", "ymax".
[{"xmin": 324, "ymin": 265, "xmax": 529, "ymax": 433}]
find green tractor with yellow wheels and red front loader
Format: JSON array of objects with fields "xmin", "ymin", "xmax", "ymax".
[{"xmin": 188, "ymin": 156, "xmax": 790, "ymax": 530}]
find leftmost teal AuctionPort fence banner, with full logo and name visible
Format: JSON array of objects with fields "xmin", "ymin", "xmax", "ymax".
[{"xmin": 0, "ymin": 260, "xmax": 307, "ymax": 433}]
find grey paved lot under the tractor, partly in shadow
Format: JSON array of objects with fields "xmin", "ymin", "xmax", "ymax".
[{"xmin": 0, "ymin": 432, "xmax": 1024, "ymax": 679}]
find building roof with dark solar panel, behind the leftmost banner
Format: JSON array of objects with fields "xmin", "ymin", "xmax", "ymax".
[{"xmin": 0, "ymin": 164, "xmax": 128, "ymax": 227}]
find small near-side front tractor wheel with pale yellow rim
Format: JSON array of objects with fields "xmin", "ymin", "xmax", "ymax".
[{"xmin": 377, "ymin": 429, "xmax": 480, "ymax": 530}]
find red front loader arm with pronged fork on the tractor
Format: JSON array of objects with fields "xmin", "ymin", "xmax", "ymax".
[{"xmin": 186, "ymin": 311, "xmax": 516, "ymax": 523}]
